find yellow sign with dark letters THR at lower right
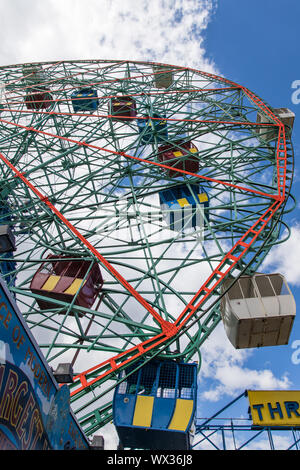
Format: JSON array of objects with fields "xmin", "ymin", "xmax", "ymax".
[{"xmin": 248, "ymin": 390, "xmax": 300, "ymax": 426}]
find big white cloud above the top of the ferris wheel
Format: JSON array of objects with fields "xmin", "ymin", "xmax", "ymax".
[{"xmin": 0, "ymin": 0, "xmax": 215, "ymax": 72}]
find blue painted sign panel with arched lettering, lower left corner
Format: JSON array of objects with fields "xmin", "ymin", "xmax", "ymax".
[{"xmin": 0, "ymin": 279, "xmax": 89, "ymax": 450}]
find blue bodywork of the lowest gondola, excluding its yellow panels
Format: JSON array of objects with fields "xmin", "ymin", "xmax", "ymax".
[{"xmin": 113, "ymin": 360, "xmax": 197, "ymax": 450}]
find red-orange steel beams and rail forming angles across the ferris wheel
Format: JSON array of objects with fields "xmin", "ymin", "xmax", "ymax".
[{"xmin": 0, "ymin": 65, "xmax": 287, "ymax": 397}]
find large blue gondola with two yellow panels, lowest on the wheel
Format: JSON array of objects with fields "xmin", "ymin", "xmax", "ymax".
[{"xmin": 113, "ymin": 361, "xmax": 197, "ymax": 450}]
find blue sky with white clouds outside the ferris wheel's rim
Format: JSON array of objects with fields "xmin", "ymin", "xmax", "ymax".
[{"xmin": 0, "ymin": 0, "xmax": 300, "ymax": 450}]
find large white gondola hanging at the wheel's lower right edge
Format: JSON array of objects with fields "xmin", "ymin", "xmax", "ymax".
[{"xmin": 221, "ymin": 274, "xmax": 296, "ymax": 349}]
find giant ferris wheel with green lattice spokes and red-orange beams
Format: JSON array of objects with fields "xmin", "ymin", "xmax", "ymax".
[{"xmin": 0, "ymin": 60, "xmax": 293, "ymax": 446}]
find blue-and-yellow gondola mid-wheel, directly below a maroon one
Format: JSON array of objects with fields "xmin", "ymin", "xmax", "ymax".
[{"xmin": 159, "ymin": 184, "xmax": 209, "ymax": 232}]
